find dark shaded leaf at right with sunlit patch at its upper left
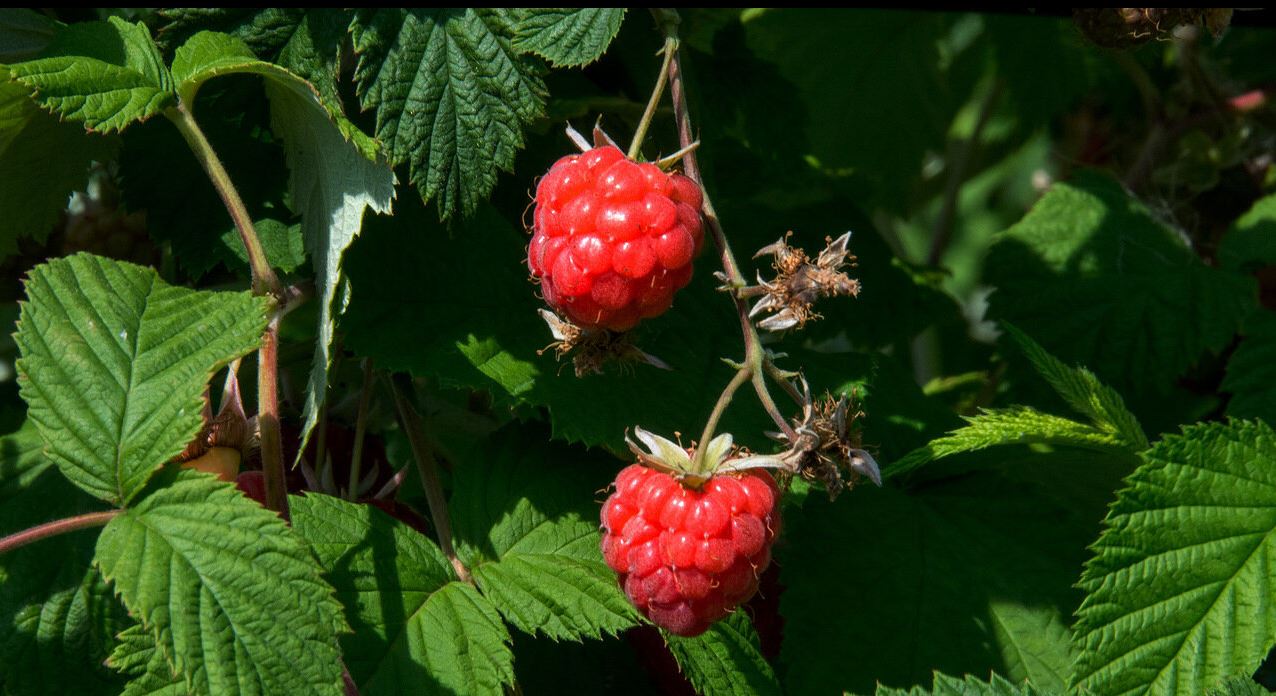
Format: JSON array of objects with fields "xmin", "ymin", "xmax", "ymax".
[{"xmin": 986, "ymin": 172, "xmax": 1257, "ymax": 395}]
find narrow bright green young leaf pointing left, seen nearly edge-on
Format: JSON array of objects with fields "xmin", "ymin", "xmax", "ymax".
[{"xmin": 887, "ymin": 406, "xmax": 1129, "ymax": 476}]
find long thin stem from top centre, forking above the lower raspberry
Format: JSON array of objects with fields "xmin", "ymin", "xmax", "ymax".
[{"xmin": 653, "ymin": 14, "xmax": 798, "ymax": 447}]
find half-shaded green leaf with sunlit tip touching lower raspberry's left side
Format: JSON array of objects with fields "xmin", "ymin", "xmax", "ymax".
[{"xmin": 450, "ymin": 430, "xmax": 641, "ymax": 640}]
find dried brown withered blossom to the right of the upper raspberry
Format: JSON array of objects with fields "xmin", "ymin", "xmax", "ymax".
[{"xmin": 749, "ymin": 232, "xmax": 860, "ymax": 331}]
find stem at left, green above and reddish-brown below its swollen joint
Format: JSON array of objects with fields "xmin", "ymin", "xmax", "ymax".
[{"xmin": 165, "ymin": 103, "xmax": 292, "ymax": 520}]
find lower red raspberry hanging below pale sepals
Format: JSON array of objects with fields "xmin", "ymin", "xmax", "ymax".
[{"xmin": 602, "ymin": 464, "xmax": 780, "ymax": 636}]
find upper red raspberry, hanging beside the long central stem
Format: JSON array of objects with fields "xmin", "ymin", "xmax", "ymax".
[{"xmin": 527, "ymin": 146, "xmax": 704, "ymax": 331}]
